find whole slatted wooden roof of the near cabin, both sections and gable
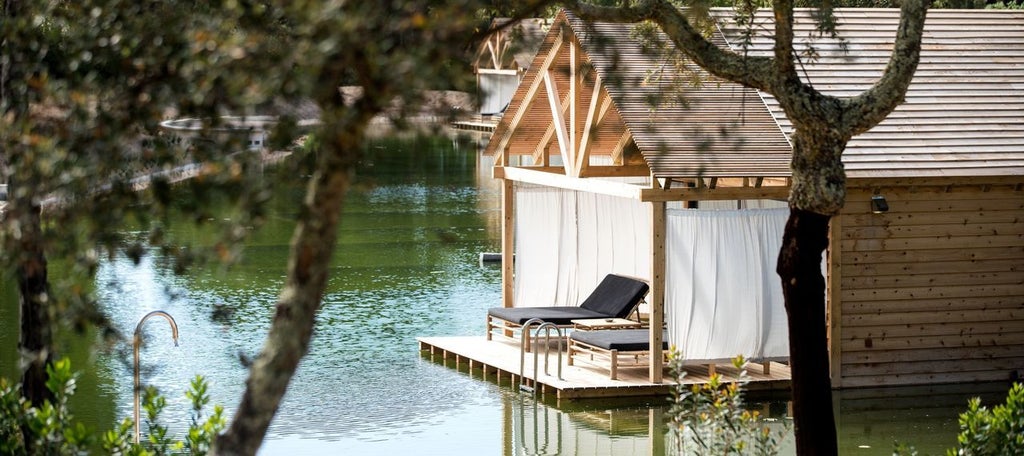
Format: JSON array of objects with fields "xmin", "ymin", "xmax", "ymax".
[{"xmin": 486, "ymin": 9, "xmax": 1024, "ymax": 183}]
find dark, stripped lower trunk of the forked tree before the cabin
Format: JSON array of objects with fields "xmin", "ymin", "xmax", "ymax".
[{"xmin": 777, "ymin": 208, "xmax": 839, "ymax": 455}]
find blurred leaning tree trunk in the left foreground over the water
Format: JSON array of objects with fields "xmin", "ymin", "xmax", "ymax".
[{"xmin": 211, "ymin": 105, "xmax": 376, "ymax": 455}]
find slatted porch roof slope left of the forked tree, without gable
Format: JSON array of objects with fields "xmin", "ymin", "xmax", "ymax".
[{"xmin": 565, "ymin": 13, "xmax": 792, "ymax": 177}]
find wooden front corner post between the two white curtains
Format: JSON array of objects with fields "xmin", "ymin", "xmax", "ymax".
[{"xmin": 648, "ymin": 201, "xmax": 666, "ymax": 383}]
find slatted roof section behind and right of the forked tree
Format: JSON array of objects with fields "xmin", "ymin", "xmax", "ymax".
[{"xmin": 715, "ymin": 8, "xmax": 1024, "ymax": 177}]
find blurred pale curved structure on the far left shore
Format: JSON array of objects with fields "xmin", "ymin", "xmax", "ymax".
[{"xmin": 160, "ymin": 116, "xmax": 278, "ymax": 151}]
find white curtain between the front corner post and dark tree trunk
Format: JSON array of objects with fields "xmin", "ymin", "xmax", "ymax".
[{"xmin": 666, "ymin": 209, "xmax": 790, "ymax": 360}]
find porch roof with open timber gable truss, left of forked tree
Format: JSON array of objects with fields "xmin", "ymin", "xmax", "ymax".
[{"xmin": 487, "ymin": 8, "xmax": 791, "ymax": 201}]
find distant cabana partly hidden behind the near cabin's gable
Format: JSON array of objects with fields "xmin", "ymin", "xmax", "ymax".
[{"xmin": 473, "ymin": 18, "xmax": 551, "ymax": 115}]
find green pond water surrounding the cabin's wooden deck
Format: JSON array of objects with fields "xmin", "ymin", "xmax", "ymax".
[{"xmin": 0, "ymin": 129, "xmax": 1005, "ymax": 455}]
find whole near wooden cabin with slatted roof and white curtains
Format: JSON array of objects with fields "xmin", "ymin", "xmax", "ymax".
[{"xmin": 486, "ymin": 9, "xmax": 1024, "ymax": 387}]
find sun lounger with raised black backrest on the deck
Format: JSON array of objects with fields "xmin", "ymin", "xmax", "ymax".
[{"xmin": 487, "ymin": 274, "xmax": 649, "ymax": 340}]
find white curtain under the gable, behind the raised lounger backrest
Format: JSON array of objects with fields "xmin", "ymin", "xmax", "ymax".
[{"xmin": 514, "ymin": 183, "xmax": 650, "ymax": 307}]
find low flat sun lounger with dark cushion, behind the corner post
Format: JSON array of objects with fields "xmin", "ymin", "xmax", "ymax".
[{"xmin": 567, "ymin": 329, "xmax": 669, "ymax": 380}]
